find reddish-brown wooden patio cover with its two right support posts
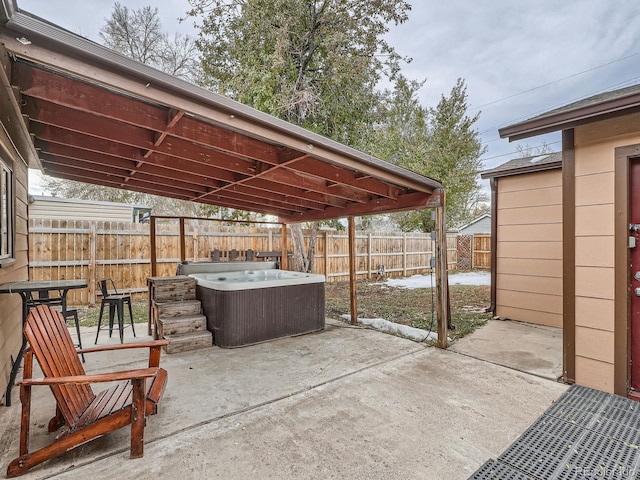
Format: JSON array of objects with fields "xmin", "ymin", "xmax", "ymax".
[{"xmin": 0, "ymin": 4, "xmax": 447, "ymax": 347}]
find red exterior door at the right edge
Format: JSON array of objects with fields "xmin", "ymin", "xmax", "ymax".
[{"xmin": 629, "ymin": 158, "xmax": 640, "ymax": 393}]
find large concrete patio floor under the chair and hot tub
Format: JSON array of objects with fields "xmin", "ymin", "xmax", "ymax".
[{"xmin": 0, "ymin": 321, "xmax": 567, "ymax": 480}]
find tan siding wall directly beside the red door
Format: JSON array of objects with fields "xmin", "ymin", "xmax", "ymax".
[{"xmin": 575, "ymin": 115, "xmax": 640, "ymax": 392}]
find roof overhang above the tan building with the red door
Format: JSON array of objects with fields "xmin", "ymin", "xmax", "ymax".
[{"xmin": 498, "ymin": 84, "xmax": 640, "ymax": 141}]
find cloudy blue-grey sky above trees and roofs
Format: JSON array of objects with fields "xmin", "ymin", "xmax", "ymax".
[{"xmin": 17, "ymin": 0, "xmax": 640, "ymax": 193}]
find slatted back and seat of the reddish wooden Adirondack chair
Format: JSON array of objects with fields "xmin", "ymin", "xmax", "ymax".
[{"xmin": 24, "ymin": 305, "xmax": 95, "ymax": 425}]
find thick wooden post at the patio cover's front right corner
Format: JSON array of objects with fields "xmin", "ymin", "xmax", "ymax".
[{"xmin": 436, "ymin": 192, "xmax": 449, "ymax": 348}]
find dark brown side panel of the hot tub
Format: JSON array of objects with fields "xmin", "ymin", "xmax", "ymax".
[{"xmin": 196, "ymin": 283, "xmax": 325, "ymax": 347}]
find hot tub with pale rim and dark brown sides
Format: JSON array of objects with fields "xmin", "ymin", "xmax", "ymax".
[{"xmin": 189, "ymin": 269, "xmax": 325, "ymax": 348}]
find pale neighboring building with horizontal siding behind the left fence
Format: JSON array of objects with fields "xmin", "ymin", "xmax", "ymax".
[{"xmin": 29, "ymin": 195, "xmax": 151, "ymax": 223}]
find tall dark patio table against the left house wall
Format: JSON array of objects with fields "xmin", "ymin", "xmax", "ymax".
[{"xmin": 0, "ymin": 279, "xmax": 87, "ymax": 407}]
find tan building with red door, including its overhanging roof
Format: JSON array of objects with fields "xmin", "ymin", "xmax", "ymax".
[{"xmin": 500, "ymin": 85, "xmax": 640, "ymax": 398}]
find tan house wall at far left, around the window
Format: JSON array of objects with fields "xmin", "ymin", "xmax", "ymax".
[{"xmin": 0, "ymin": 153, "xmax": 28, "ymax": 402}]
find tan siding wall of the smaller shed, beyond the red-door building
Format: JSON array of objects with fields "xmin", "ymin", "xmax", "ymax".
[{"xmin": 496, "ymin": 169, "xmax": 562, "ymax": 327}]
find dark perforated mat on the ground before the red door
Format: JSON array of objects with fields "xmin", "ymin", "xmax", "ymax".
[{"xmin": 469, "ymin": 385, "xmax": 640, "ymax": 480}]
